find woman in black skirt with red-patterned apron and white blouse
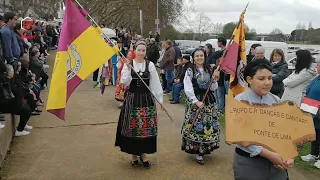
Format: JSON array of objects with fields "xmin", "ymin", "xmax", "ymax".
[{"xmin": 115, "ymin": 41, "xmax": 163, "ymax": 168}]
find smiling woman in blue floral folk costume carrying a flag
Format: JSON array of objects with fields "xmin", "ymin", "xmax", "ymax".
[{"xmin": 181, "ymin": 49, "xmax": 220, "ymax": 165}]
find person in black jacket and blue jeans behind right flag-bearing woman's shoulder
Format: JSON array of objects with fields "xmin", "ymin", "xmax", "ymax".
[{"xmin": 170, "ymin": 55, "xmax": 192, "ymax": 104}]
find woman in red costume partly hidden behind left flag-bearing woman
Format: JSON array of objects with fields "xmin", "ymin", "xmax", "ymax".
[{"xmin": 115, "ymin": 50, "xmax": 136, "ymax": 108}]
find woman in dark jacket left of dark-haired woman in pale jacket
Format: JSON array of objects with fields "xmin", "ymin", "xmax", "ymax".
[{"xmin": 270, "ymin": 49, "xmax": 290, "ymax": 98}]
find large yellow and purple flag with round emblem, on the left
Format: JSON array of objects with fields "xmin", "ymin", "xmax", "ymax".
[{"xmin": 46, "ymin": 0, "xmax": 119, "ymax": 120}]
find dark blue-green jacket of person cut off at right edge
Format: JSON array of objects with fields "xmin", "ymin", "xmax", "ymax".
[{"xmin": 306, "ymin": 75, "xmax": 320, "ymax": 130}]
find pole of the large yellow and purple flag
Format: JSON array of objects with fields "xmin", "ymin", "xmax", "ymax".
[{"xmin": 74, "ymin": 0, "xmax": 174, "ymax": 122}]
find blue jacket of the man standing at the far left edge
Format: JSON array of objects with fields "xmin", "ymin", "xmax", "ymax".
[{"xmin": 0, "ymin": 25, "xmax": 20, "ymax": 62}]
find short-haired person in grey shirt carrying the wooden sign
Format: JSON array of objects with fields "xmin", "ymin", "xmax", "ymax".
[{"xmin": 233, "ymin": 59, "xmax": 294, "ymax": 180}]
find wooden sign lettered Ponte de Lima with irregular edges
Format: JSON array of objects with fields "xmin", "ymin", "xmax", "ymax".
[{"xmin": 226, "ymin": 96, "xmax": 316, "ymax": 160}]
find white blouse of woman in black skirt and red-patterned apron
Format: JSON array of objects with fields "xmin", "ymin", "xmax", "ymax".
[{"xmin": 120, "ymin": 60, "xmax": 163, "ymax": 104}]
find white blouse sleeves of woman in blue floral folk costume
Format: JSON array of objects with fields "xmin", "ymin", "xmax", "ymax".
[{"xmin": 183, "ymin": 68, "xmax": 218, "ymax": 103}]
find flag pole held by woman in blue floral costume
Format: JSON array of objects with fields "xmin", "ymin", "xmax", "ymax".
[{"xmin": 187, "ymin": 2, "xmax": 249, "ymax": 136}]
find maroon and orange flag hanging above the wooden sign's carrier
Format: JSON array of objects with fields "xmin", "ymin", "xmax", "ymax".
[{"xmin": 220, "ymin": 11, "xmax": 247, "ymax": 96}]
